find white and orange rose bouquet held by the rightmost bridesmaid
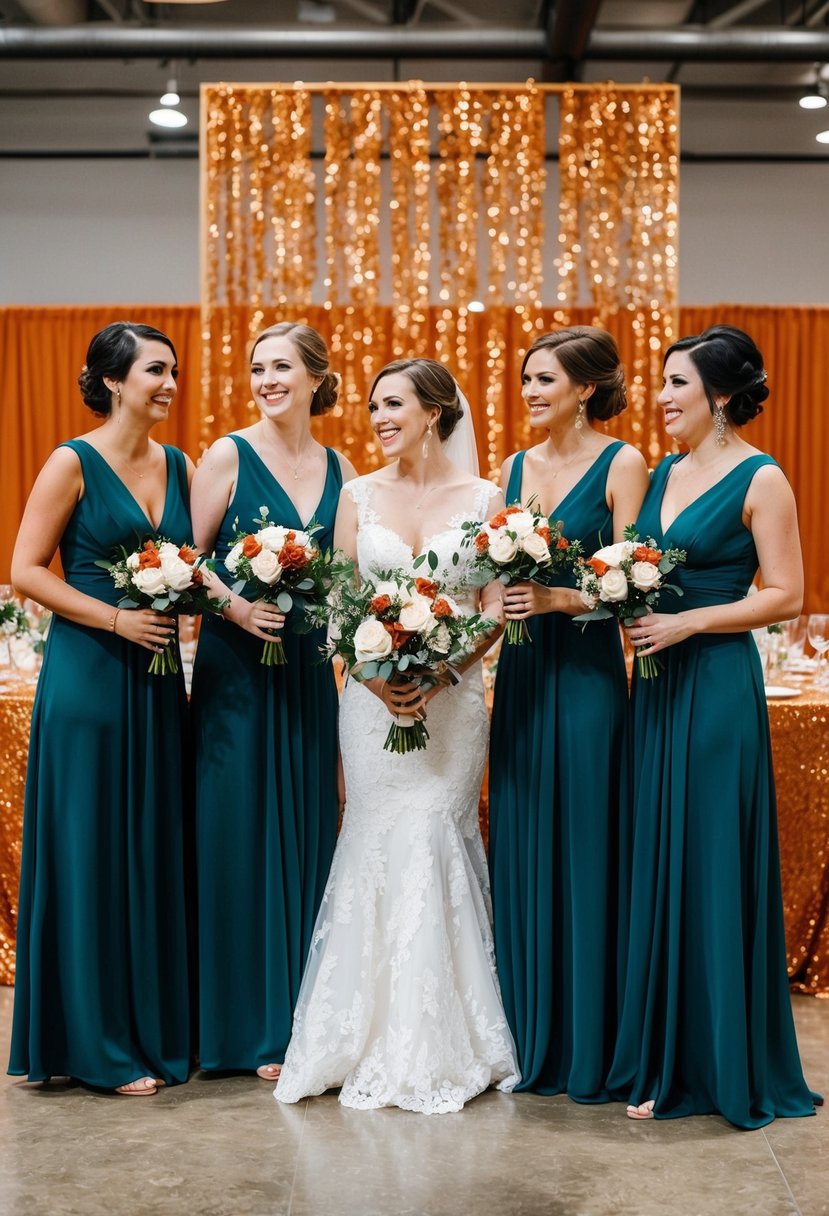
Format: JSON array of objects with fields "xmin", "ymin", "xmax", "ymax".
[{"xmin": 573, "ymin": 525, "xmax": 686, "ymax": 680}]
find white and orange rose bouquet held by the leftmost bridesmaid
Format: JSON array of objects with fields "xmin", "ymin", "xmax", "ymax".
[{"xmin": 95, "ymin": 537, "xmax": 227, "ymax": 676}]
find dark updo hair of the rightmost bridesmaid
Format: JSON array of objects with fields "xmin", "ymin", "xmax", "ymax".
[{"xmin": 662, "ymin": 325, "xmax": 768, "ymax": 427}]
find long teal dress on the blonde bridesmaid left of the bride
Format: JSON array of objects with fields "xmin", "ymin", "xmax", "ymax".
[{"xmin": 192, "ymin": 435, "xmax": 343, "ymax": 1070}]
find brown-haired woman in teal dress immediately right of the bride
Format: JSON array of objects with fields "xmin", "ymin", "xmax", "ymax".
[{"xmin": 490, "ymin": 326, "xmax": 648, "ymax": 1102}]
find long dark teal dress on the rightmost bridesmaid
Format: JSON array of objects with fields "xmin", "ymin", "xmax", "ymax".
[{"xmin": 608, "ymin": 455, "xmax": 816, "ymax": 1128}]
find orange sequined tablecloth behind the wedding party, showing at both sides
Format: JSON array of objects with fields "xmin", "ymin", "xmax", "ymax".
[{"xmin": 0, "ymin": 685, "xmax": 829, "ymax": 996}]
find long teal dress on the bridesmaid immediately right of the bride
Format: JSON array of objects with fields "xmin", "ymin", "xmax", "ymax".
[{"xmin": 490, "ymin": 443, "xmax": 627, "ymax": 1102}]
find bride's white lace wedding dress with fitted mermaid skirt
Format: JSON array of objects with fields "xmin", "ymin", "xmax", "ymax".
[{"xmin": 275, "ymin": 478, "xmax": 519, "ymax": 1114}]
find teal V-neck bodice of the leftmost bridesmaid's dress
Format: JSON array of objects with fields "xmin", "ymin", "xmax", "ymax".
[{"xmin": 61, "ymin": 439, "xmax": 193, "ymax": 604}]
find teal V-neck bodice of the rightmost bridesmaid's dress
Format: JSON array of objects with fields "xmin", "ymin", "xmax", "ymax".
[{"xmin": 637, "ymin": 454, "xmax": 776, "ymax": 612}]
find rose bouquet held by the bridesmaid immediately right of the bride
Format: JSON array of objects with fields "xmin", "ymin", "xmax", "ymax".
[{"xmin": 463, "ymin": 500, "xmax": 582, "ymax": 646}]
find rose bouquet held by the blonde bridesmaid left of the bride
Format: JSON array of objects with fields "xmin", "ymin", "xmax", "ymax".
[{"xmin": 225, "ymin": 507, "xmax": 332, "ymax": 668}]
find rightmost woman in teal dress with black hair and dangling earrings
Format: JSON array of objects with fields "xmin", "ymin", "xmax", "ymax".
[{"xmin": 609, "ymin": 325, "xmax": 817, "ymax": 1128}]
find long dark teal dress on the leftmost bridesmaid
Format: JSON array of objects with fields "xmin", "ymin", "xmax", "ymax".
[{"xmin": 9, "ymin": 439, "xmax": 192, "ymax": 1088}]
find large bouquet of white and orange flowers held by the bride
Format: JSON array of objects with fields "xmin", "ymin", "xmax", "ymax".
[{"xmin": 327, "ymin": 563, "xmax": 495, "ymax": 755}]
